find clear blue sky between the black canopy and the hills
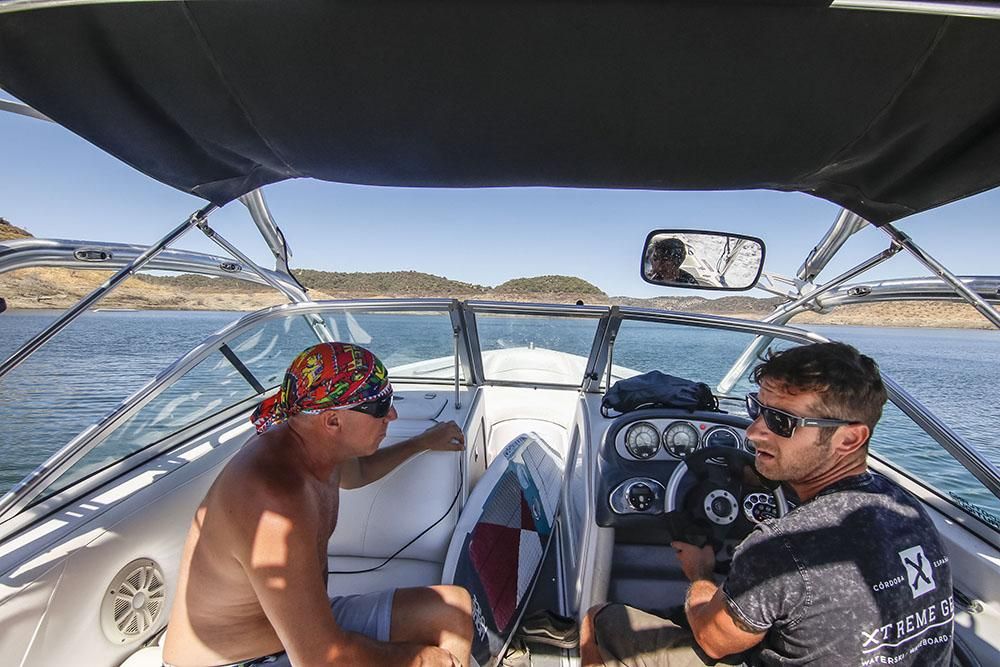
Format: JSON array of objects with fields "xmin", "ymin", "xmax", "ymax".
[{"xmin": 0, "ymin": 95, "xmax": 1000, "ymax": 297}]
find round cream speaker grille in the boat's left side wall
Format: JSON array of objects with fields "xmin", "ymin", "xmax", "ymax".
[{"xmin": 101, "ymin": 558, "xmax": 167, "ymax": 644}]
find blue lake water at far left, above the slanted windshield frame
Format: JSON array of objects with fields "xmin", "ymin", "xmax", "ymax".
[{"xmin": 0, "ymin": 310, "xmax": 240, "ymax": 495}]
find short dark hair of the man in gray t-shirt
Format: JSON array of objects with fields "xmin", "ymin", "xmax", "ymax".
[{"xmin": 750, "ymin": 343, "xmax": 886, "ymax": 433}]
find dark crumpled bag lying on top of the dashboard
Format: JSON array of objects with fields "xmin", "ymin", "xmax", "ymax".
[{"xmin": 601, "ymin": 371, "xmax": 719, "ymax": 417}]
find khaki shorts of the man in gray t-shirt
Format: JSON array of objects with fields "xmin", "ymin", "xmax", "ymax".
[{"xmin": 594, "ymin": 603, "xmax": 744, "ymax": 667}]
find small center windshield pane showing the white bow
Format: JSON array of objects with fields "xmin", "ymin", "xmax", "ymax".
[{"xmin": 476, "ymin": 313, "xmax": 599, "ymax": 387}]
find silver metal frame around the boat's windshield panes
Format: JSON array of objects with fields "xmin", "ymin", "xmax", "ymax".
[{"xmin": 0, "ymin": 299, "xmax": 1000, "ymax": 535}]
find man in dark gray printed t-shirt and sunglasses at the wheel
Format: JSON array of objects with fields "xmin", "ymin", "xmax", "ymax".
[{"xmin": 580, "ymin": 343, "xmax": 954, "ymax": 667}]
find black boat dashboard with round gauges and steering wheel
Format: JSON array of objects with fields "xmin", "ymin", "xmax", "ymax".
[{"xmin": 594, "ymin": 408, "xmax": 787, "ymax": 543}]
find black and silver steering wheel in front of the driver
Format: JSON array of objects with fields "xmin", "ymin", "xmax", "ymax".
[{"xmin": 664, "ymin": 447, "xmax": 788, "ymax": 555}]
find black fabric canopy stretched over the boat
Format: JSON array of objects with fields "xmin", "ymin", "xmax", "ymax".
[{"xmin": 0, "ymin": 0, "xmax": 1000, "ymax": 224}]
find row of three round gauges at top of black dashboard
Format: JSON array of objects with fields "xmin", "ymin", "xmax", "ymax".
[{"xmin": 615, "ymin": 419, "xmax": 754, "ymax": 461}]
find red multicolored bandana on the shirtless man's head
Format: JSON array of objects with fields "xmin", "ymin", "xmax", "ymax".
[{"xmin": 250, "ymin": 343, "xmax": 392, "ymax": 433}]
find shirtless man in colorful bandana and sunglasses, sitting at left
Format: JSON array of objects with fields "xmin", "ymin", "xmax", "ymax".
[{"xmin": 163, "ymin": 343, "xmax": 472, "ymax": 667}]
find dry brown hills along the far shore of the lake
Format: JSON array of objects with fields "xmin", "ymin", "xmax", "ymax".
[{"xmin": 0, "ymin": 218, "xmax": 991, "ymax": 329}]
